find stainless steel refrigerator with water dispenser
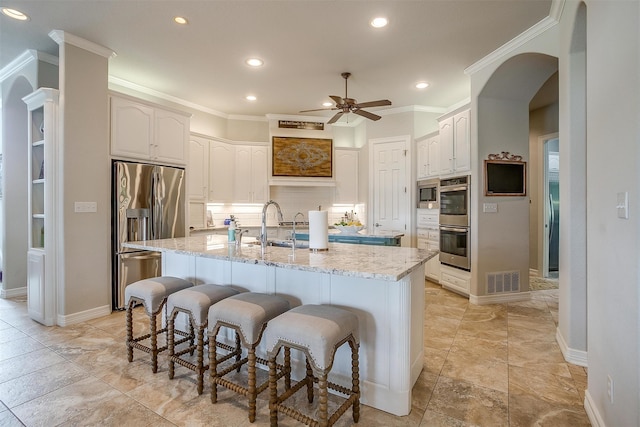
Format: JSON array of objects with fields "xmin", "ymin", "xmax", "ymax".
[{"xmin": 111, "ymin": 161, "xmax": 186, "ymax": 310}]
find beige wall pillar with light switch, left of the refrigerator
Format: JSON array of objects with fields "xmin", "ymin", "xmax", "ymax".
[{"xmin": 58, "ymin": 43, "xmax": 111, "ymax": 316}]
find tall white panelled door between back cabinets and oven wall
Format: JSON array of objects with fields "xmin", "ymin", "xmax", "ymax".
[{"xmin": 370, "ymin": 137, "xmax": 409, "ymax": 241}]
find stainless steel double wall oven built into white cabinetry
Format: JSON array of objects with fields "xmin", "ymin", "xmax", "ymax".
[{"xmin": 440, "ymin": 175, "xmax": 471, "ymax": 271}]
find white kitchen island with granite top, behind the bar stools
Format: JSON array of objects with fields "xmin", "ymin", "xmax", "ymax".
[{"xmin": 125, "ymin": 235, "xmax": 437, "ymax": 415}]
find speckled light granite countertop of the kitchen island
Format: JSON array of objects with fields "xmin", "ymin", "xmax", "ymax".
[{"xmin": 123, "ymin": 234, "xmax": 438, "ymax": 281}]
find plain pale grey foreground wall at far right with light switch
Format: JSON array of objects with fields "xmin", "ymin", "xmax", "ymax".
[{"xmin": 576, "ymin": 1, "xmax": 640, "ymax": 426}]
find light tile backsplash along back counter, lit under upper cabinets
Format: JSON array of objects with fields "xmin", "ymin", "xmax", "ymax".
[{"xmin": 207, "ymin": 186, "xmax": 366, "ymax": 227}]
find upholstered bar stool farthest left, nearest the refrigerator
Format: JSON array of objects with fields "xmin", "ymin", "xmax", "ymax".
[{"xmin": 124, "ymin": 276, "xmax": 193, "ymax": 374}]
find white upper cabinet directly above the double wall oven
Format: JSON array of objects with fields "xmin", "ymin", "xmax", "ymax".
[{"xmin": 438, "ymin": 110, "xmax": 471, "ymax": 175}]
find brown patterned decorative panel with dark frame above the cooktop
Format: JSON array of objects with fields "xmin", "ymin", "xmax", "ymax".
[{"xmin": 271, "ymin": 136, "xmax": 333, "ymax": 178}]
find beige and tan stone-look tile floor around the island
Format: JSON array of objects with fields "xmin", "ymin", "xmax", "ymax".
[{"xmin": 0, "ymin": 282, "xmax": 590, "ymax": 427}]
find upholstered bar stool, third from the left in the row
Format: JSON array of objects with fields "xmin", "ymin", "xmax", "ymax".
[{"xmin": 208, "ymin": 292, "xmax": 291, "ymax": 422}]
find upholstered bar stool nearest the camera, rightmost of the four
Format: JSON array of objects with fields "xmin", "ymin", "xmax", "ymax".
[{"xmin": 265, "ymin": 305, "xmax": 360, "ymax": 427}]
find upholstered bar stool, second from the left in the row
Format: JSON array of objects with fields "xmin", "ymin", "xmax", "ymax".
[{"xmin": 167, "ymin": 284, "xmax": 239, "ymax": 394}]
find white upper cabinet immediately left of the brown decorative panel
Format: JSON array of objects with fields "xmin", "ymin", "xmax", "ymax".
[{"xmin": 234, "ymin": 145, "xmax": 269, "ymax": 203}]
